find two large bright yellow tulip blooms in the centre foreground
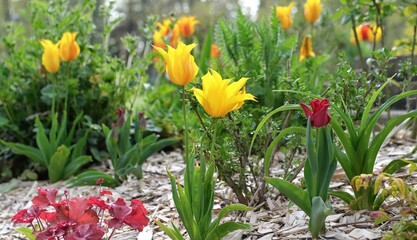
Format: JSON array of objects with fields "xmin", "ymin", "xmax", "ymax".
[{"xmin": 154, "ymin": 42, "xmax": 256, "ymax": 118}]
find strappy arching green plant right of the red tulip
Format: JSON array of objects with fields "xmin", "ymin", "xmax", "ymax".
[{"xmin": 330, "ymin": 80, "xmax": 417, "ymax": 210}]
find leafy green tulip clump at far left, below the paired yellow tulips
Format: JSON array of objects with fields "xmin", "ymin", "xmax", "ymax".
[{"xmin": 0, "ymin": 113, "xmax": 91, "ymax": 183}]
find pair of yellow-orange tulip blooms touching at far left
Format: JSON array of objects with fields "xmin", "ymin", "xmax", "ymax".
[{"xmin": 40, "ymin": 32, "xmax": 80, "ymax": 73}]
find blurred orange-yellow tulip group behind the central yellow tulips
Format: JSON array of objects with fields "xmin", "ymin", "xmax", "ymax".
[{"xmin": 153, "ymin": 16, "xmax": 200, "ymax": 48}]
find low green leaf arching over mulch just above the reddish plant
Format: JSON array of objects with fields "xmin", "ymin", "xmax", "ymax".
[{"xmin": 67, "ymin": 170, "xmax": 120, "ymax": 187}]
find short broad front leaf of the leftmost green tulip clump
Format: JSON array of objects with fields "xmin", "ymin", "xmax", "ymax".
[{"xmin": 48, "ymin": 145, "xmax": 70, "ymax": 183}]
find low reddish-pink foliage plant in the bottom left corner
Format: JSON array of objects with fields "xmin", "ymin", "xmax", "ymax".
[{"xmin": 12, "ymin": 188, "xmax": 149, "ymax": 240}]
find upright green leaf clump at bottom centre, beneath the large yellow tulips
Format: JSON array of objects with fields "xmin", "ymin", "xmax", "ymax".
[{"xmin": 156, "ymin": 156, "xmax": 252, "ymax": 240}]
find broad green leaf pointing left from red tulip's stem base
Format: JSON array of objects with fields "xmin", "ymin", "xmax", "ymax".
[{"xmin": 265, "ymin": 177, "xmax": 311, "ymax": 216}]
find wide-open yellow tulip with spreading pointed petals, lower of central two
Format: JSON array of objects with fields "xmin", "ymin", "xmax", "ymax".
[{"xmin": 192, "ymin": 70, "xmax": 256, "ymax": 118}]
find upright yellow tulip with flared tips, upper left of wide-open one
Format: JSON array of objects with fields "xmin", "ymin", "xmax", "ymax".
[{"xmin": 154, "ymin": 42, "xmax": 198, "ymax": 86}]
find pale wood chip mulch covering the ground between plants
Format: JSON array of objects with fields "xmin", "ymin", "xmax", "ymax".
[{"xmin": 0, "ymin": 131, "xmax": 417, "ymax": 240}]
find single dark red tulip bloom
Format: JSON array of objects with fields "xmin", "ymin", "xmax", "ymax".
[{"xmin": 300, "ymin": 99, "xmax": 331, "ymax": 128}]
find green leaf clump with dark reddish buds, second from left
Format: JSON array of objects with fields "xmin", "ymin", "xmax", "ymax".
[{"xmin": 68, "ymin": 109, "xmax": 178, "ymax": 186}]
